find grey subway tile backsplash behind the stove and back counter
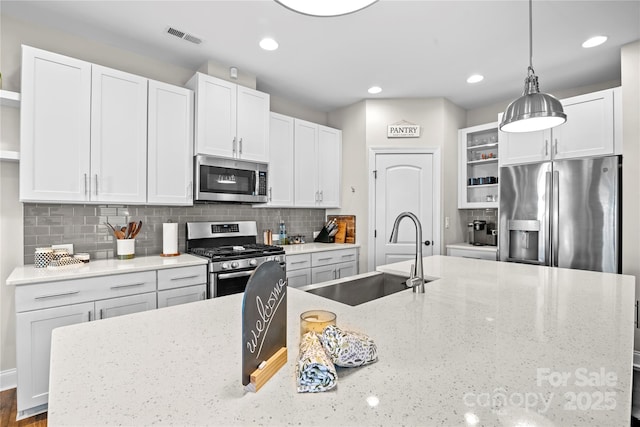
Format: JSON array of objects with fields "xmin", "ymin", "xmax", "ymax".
[{"xmin": 24, "ymin": 203, "xmax": 326, "ymax": 264}]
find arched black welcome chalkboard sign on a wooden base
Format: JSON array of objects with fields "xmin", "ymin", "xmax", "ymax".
[{"xmin": 242, "ymin": 261, "xmax": 287, "ymax": 391}]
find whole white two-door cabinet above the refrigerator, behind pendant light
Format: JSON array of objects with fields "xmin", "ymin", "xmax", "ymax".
[{"xmin": 500, "ymin": 88, "xmax": 622, "ymax": 166}]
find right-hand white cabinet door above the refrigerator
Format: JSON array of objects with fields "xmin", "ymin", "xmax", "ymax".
[{"xmin": 551, "ymin": 90, "xmax": 614, "ymax": 159}]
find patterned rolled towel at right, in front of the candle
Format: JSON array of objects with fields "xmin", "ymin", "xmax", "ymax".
[{"xmin": 320, "ymin": 325, "xmax": 378, "ymax": 368}]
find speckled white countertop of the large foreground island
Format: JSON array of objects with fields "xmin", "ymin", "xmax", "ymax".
[{"xmin": 48, "ymin": 256, "xmax": 635, "ymax": 426}]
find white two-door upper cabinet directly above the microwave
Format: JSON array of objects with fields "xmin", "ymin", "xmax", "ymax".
[{"xmin": 187, "ymin": 73, "xmax": 270, "ymax": 162}]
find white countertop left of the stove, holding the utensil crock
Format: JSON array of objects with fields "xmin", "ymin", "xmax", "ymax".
[{"xmin": 7, "ymin": 254, "xmax": 207, "ymax": 285}]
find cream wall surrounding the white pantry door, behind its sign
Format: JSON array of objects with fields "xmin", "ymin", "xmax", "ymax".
[{"xmin": 327, "ymin": 98, "xmax": 466, "ymax": 272}]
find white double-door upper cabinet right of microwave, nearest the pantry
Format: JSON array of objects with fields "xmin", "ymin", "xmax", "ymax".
[{"xmin": 294, "ymin": 119, "xmax": 342, "ymax": 208}]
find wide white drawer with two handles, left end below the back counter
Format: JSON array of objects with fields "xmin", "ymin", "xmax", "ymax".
[{"xmin": 15, "ymin": 271, "xmax": 156, "ymax": 313}]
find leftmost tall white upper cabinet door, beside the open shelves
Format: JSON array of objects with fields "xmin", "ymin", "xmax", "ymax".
[{"xmin": 20, "ymin": 46, "xmax": 91, "ymax": 202}]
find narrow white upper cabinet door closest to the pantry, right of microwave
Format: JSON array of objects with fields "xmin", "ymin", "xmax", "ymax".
[{"xmin": 317, "ymin": 126, "xmax": 342, "ymax": 208}]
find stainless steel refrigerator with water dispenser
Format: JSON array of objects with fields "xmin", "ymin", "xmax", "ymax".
[{"xmin": 498, "ymin": 156, "xmax": 622, "ymax": 273}]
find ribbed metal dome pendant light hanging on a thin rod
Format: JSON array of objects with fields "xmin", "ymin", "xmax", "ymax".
[{"xmin": 500, "ymin": 0, "xmax": 567, "ymax": 132}]
